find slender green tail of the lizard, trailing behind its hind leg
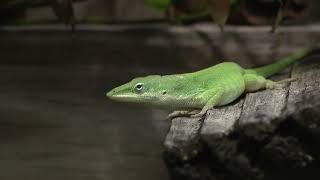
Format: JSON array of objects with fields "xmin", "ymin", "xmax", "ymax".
[{"xmin": 246, "ymin": 49, "xmax": 312, "ymax": 77}]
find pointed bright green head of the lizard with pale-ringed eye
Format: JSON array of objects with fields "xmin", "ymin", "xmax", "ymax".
[{"xmin": 106, "ymin": 75, "xmax": 167, "ymax": 104}]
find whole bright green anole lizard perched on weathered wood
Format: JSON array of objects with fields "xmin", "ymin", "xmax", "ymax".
[{"xmin": 107, "ymin": 49, "xmax": 311, "ymax": 118}]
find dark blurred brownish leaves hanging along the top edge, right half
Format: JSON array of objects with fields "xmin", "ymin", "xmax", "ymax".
[{"xmin": 145, "ymin": 0, "xmax": 311, "ymax": 31}]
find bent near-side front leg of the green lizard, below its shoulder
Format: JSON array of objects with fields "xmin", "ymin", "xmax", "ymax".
[{"xmin": 191, "ymin": 88, "xmax": 224, "ymax": 117}]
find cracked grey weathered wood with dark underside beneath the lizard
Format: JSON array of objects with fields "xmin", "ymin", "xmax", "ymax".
[{"xmin": 164, "ymin": 54, "xmax": 320, "ymax": 180}]
